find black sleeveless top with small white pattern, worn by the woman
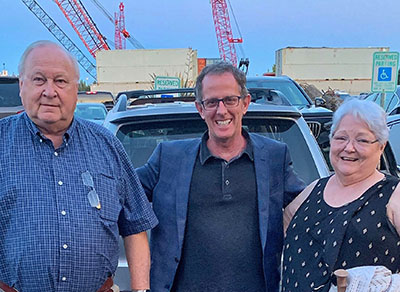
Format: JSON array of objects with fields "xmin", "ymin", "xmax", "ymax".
[{"xmin": 282, "ymin": 176, "xmax": 400, "ymax": 292}]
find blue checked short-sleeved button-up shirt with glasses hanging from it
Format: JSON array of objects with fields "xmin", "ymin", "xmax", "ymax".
[{"xmin": 0, "ymin": 113, "xmax": 157, "ymax": 292}]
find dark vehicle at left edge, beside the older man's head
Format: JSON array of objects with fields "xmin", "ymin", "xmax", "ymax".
[{"xmin": 0, "ymin": 76, "xmax": 24, "ymax": 118}]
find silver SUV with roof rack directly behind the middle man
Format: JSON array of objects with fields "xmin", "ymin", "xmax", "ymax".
[{"xmin": 104, "ymin": 89, "xmax": 329, "ymax": 290}]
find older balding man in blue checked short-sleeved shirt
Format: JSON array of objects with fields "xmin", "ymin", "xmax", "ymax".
[{"xmin": 0, "ymin": 41, "xmax": 157, "ymax": 292}]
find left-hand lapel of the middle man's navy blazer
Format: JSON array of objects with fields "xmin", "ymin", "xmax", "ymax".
[{"xmin": 174, "ymin": 139, "xmax": 201, "ymax": 249}]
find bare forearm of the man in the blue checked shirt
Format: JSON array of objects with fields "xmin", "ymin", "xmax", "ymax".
[{"xmin": 124, "ymin": 231, "xmax": 150, "ymax": 290}]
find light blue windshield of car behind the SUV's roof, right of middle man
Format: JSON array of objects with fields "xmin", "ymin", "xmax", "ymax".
[{"xmin": 246, "ymin": 78, "xmax": 310, "ymax": 106}]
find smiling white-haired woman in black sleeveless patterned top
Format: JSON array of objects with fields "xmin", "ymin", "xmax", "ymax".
[{"xmin": 282, "ymin": 100, "xmax": 400, "ymax": 292}]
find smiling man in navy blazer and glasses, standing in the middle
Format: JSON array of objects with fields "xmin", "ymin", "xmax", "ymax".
[{"xmin": 137, "ymin": 63, "xmax": 304, "ymax": 292}]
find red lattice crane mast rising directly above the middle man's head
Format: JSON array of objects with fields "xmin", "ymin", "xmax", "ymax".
[{"xmin": 211, "ymin": 0, "xmax": 243, "ymax": 67}]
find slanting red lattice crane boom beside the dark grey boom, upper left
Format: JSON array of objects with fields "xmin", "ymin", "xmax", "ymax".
[{"xmin": 54, "ymin": 0, "xmax": 110, "ymax": 57}]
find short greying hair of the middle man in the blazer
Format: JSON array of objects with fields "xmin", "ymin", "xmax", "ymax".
[{"xmin": 195, "ymin": 62, "xmax": 248, "ymax": 102}]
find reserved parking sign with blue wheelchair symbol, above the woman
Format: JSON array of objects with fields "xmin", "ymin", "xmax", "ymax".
[{"xmin": 371, "ymin": 52, "xmax": 399, "ymax": 107}]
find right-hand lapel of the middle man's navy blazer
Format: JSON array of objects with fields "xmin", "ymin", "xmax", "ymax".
[{"xmin": 250, "ymin": 136, "xmax": 270, "ymax": 252}]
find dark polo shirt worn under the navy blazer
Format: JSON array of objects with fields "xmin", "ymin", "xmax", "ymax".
[{"xmin": 171, "ymin": 131, "xmax": 265, "ymax": 292}]
